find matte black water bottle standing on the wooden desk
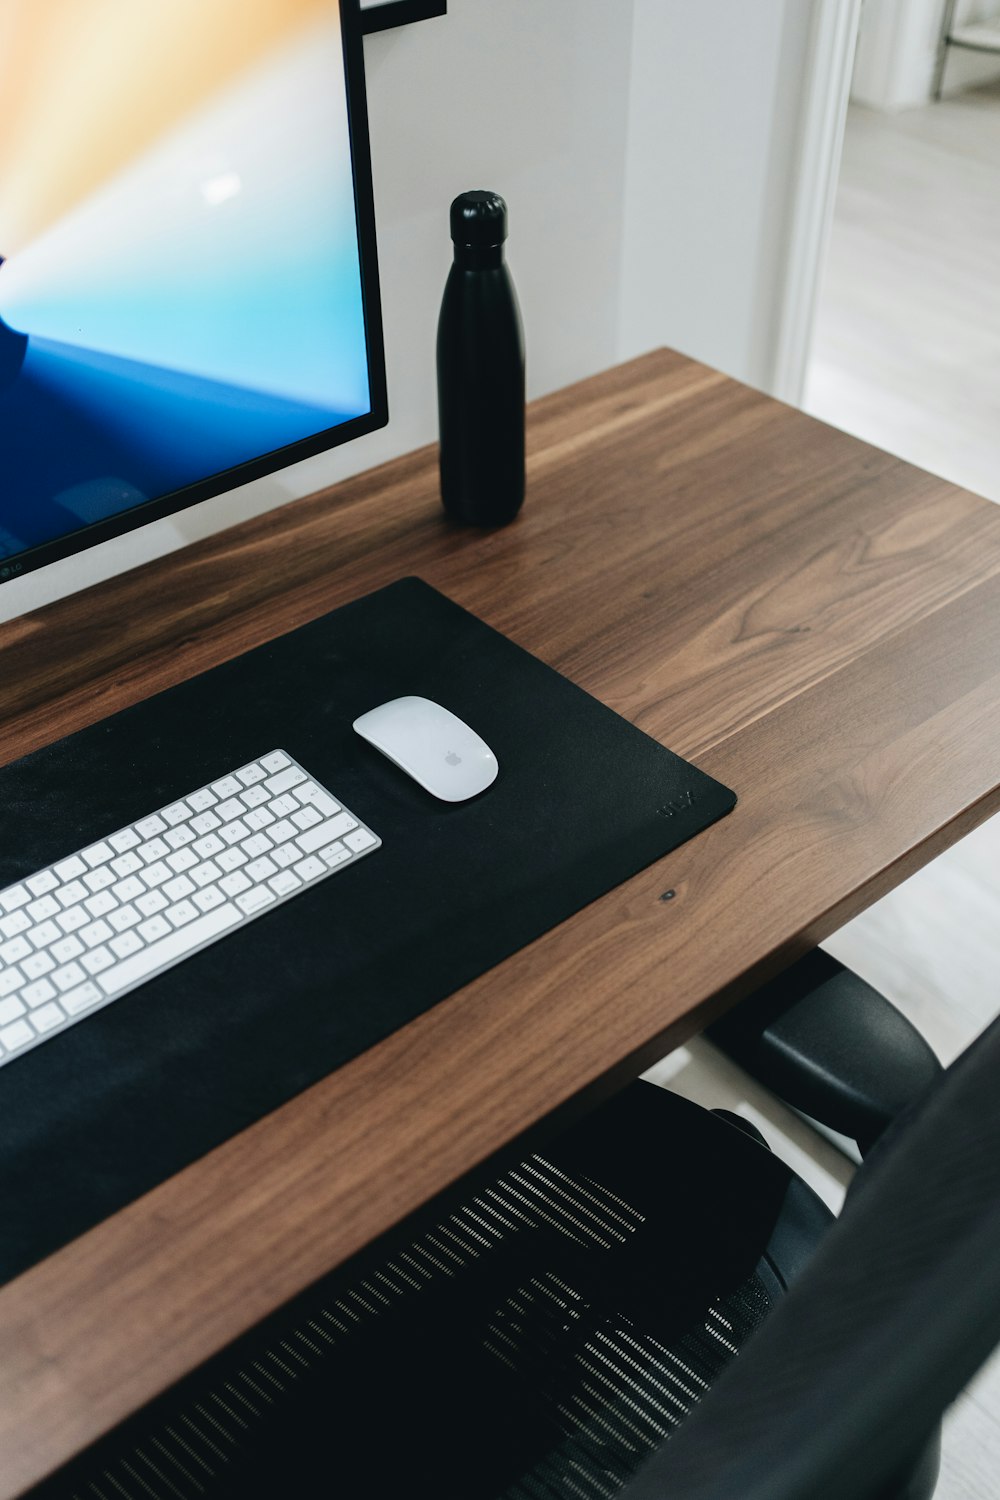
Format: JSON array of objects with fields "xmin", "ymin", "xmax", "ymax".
[{"xmin": 438, "ymin": 192, "xmax": 525, "ymax": 527}]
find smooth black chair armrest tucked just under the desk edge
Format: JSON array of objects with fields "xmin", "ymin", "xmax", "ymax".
[{"xmin": 706, "ymin": 948, "xmax": 942, "ymax": 1155}]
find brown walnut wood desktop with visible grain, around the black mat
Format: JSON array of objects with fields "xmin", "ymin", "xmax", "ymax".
[{"xmin": 0, "ymin": 351, "xmax": 1000, "ymax": 1497}]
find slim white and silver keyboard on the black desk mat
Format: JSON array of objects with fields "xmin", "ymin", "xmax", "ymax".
[{"xmin": 0, "ymin": 750, "xmax": 381, "ymax": 1067}]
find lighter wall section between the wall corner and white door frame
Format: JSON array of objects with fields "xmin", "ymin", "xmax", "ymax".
[{"xmin": 618, "ymin": 0, "xmax": 817, "ymax": 389}]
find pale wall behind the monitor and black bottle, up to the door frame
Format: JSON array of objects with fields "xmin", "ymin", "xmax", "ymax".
[{"xmin": 0, "ymin": 0, "xmax": 827, "ymax": 618}]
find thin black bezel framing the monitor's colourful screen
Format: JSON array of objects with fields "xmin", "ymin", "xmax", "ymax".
[{"xmin": 0, "ymin": 0, "xmax": 388, "ymax": 585}]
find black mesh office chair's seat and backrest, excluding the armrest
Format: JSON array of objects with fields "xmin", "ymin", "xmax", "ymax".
[{"xmin": 42, "ymin": 1022, "xmax": 1000, "ymax": 1500}]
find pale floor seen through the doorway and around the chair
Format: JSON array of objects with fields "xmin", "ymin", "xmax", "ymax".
[{"xmin": 649, "ymin": 83, "xmax": 1000, "ymax": 1500}]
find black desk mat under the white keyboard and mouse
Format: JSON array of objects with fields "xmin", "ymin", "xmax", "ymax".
[{"xmin": 0, "ymin": 579, "xmax": 736, "ymax": 1283}]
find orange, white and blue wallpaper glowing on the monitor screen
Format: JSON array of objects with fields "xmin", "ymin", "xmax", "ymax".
[{"xmin": 0, "ymin": 0, "xmax": 370, "ymax": 557}]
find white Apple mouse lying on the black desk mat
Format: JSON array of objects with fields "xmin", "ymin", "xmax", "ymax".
[{"xmin": 354, "ymin": 698, "xmax": 499, "ymax": 803}]
